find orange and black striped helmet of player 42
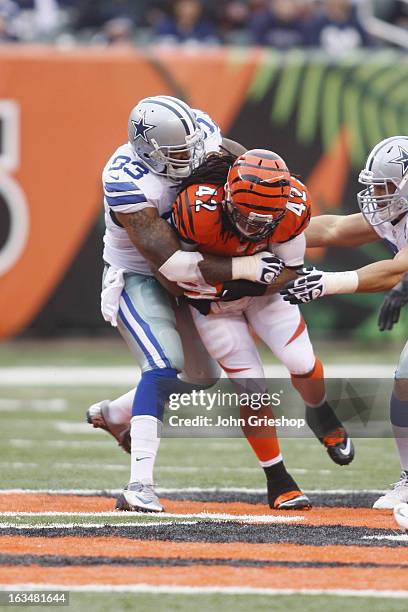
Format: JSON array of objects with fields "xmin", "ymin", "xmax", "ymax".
[{"xmin": 225, "ymin": 149, "xmax": 290, "ymax": 242}]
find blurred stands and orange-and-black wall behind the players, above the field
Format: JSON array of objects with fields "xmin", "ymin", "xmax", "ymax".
[{"xmin": 0, "ymin": 0, "xmax": 408, "ymax": 342}]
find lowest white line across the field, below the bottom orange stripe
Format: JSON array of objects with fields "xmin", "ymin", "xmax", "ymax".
[{"xmin": 0, "ymin": 582, "xmax": 408, "ymax": 606}]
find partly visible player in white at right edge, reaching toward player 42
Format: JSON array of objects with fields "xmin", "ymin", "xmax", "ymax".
[{"xmin": 282, "ymin": 136, "xmax": 408, "ymax": 509}]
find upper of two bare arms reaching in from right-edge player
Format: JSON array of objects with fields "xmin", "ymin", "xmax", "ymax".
[{"xmin": 305, "ymin": 213, "xmax": 379, "ymax": 248}]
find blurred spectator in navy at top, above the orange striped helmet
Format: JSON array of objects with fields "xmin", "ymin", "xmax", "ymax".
[{"xmin": 249, "ymin": 0, "xmax": 307, "ymax": 49}]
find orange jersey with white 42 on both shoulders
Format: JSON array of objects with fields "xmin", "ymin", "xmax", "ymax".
[{"xmin": 172, "ymin": 177, "xmax": 311, "ymax": 257}]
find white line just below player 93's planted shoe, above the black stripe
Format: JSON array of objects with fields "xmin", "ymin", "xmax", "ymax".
[{"xmin": 0, "ymin": 511, "xmax": 305, "ymax": 528}]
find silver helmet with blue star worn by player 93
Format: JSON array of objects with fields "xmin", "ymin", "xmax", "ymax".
[{"xmin": 128, "ymin": 96, "xmax": 205, "ymax": 180}]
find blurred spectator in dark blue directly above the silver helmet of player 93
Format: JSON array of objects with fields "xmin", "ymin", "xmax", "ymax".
[{"xmin": 154, "ymin": 0, "xmax": 219, "ymax": 44}]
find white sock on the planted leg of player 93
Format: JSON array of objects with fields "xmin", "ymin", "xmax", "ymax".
[{"xmin": 130, "ymin": 415, "xmax": 162, "ymax": 484}]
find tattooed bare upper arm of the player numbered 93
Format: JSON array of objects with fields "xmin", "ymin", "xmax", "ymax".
[{"xmin": 116, "ymin": 208, "xmax": 180, "ymax": 268}]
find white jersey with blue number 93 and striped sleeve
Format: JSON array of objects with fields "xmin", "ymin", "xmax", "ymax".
[{"xmin": 102, "ymin": 110, "xmax": 222, "ymax": 275}]
